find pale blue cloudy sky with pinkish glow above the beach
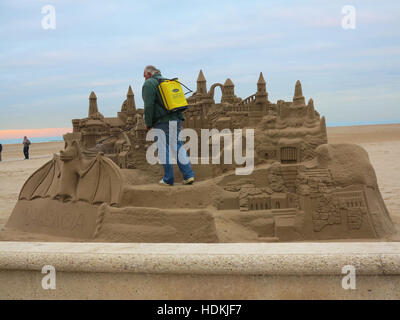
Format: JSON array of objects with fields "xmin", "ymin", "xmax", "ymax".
[{"xmin": 0, "ymin": 0, "xmax": 400, "ymax": 139}]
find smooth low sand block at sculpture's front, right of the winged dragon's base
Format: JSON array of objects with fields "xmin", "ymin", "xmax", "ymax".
[{"xmin": 94, "ymin": 205, "xmax": 219, "ymax": 243}]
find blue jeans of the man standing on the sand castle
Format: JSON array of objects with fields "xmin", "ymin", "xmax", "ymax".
[{"xmin": 154, "ymin": 120, "xmax": 194, "ymax": 185}]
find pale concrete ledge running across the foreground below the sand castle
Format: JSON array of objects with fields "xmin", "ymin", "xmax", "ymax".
[{"xmin": 0, "ymin": 242, "xmax": 400, "ymax": 299}]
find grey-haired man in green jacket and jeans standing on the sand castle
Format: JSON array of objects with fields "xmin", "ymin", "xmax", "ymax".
[{"xmin": 142, "ymin": 66, "xmax": 194, "ymax": 186}]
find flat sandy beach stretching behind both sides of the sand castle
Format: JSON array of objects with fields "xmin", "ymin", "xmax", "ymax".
[{"xmin": 0, "ymin": 124, "xmax": 400, "ymax": 238}]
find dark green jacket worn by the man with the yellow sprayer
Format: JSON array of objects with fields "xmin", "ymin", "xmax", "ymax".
[{"xmin": 142, "ymin": 73, "xmax": 185, "ymax": 127}]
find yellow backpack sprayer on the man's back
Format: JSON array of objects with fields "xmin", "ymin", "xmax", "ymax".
[{"xmin": 158, "ymin": 78, "xmax": 193, "ymax": 112}]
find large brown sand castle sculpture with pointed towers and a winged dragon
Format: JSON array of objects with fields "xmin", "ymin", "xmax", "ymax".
[{"xmin": 6, "ymin": 71, "xmax": 395, "ymax": 242}]
